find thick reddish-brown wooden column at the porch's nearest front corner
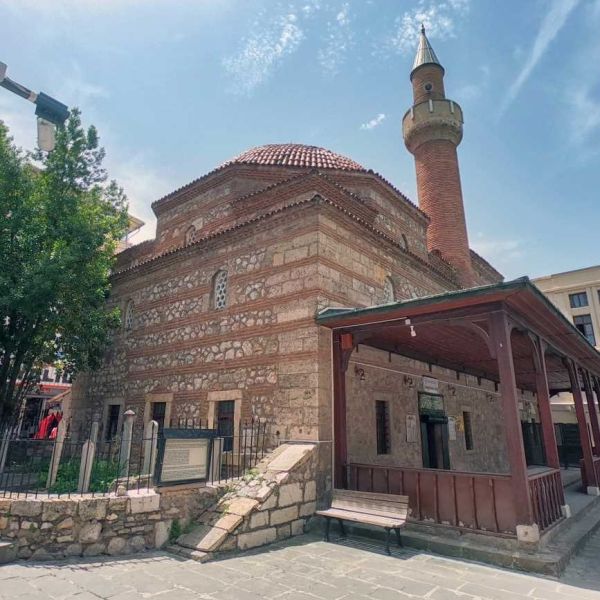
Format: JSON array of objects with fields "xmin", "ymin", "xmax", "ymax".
[{"xmin": 490, "ymin": 312, "xmax": 537, "ymax": 528}]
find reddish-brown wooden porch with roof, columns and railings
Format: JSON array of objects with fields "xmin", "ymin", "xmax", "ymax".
[{"xmin": 318, "ymin": 278, "xmax": 600, "ymax": 542}]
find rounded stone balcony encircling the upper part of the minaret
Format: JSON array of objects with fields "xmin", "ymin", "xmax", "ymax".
[{"xmin": 402, "ymin": 98, "xmax": 463, "ymax": 153}]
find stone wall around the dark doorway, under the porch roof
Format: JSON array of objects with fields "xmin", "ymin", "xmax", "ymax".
[{"xmin": 346, "ymin": 346, "xmax": 539, "ymax": 473}]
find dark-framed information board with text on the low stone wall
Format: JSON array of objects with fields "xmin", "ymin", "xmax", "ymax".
[{"xmin": 156, "ymin": 429, "xmax": 215, "ymax": 486}]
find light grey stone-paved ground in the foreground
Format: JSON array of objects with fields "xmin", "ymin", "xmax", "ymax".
[{"xmin": 0, "ymin": 534, "xmax": 600, "ymax": 600}]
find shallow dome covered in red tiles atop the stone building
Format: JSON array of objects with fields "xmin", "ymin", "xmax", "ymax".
[{"xmin": 222, "ymin": 144, "xmax": 366, "ymax": 171}]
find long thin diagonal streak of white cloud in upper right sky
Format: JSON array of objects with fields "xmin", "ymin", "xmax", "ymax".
[{"xmin": 501, "ymin": 0, "xmax": 579, "ymax": 112}]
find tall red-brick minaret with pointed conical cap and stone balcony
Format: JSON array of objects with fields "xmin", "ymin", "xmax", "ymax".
[{"xmin": 402, "ymin": 26, "xmax": 475, "ymax": 287}]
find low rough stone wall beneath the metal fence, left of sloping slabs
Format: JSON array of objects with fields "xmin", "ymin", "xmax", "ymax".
[{"xmin": 0, "ymin": 487, "xmax": 218, "ymax": 560}]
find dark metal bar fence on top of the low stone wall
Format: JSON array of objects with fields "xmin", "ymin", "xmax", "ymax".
[{"xmin": 0, "ymin": 414, "xmax": 267, "ymax": 497}]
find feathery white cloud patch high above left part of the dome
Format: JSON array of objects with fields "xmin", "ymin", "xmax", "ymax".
[{"xmin": 223, "ymin": 12, "xmax": 304, "ymax": 94}]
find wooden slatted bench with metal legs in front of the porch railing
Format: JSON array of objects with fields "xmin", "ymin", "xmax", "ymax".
[{"xmin": 316, "ymin": 490, "xmax": 408, "ymax": 554}]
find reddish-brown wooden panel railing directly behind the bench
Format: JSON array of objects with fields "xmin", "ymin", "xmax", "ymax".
[{"xmin": 347, "ymin": 463, "xmax": 517, "ymax": 536}]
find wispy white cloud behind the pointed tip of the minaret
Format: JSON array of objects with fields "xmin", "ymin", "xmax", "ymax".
[{"xmin": 388, "ymin": 0, "xmax": 470, "ymax": 54}]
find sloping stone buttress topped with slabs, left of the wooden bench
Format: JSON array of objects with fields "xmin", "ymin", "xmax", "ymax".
[{"xmin": 166, "ymin": 443, "xmax": 317, "ymax": 562}]
